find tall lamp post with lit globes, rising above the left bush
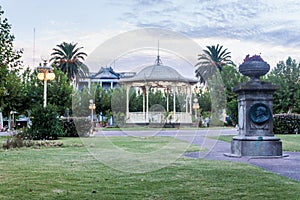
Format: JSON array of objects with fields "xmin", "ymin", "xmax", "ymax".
[{"xmin": 37, "ymin": 60, "xmax": 55, "ymax": 108}]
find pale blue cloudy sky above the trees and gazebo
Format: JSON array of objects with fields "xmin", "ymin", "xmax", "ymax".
[{"xmin": 0, "ymin": 0, "xmax": 300, "ymax": 77}]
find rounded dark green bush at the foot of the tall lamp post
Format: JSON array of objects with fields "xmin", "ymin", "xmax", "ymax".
[{"xmin": 28, "ymin": 104, "xmax": 63, "ymax": 140}]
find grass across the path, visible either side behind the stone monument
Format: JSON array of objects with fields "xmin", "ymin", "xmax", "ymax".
[{"xmin": 211, "ymin": 135, "xmax": 300, "ymax": 152}]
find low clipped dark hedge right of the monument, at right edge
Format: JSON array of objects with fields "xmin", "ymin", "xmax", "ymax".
[{"xmin": 273, "ymin": 114, "xmax": 300, "ymax": 134}]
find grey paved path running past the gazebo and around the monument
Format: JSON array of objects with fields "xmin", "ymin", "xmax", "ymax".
[{"xmin": 96, "ymin": 129, "xmax": 300, "ymax": 181}]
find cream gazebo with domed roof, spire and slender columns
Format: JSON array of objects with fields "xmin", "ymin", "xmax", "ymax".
[{"xmin": 120, "ymin": 55, "xmax": 198, "ymax": 124}]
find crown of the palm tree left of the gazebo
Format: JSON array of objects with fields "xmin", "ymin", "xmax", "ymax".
[{"xmin": 50, "ymin": 42, "xmax": 89, "ymax": 81}]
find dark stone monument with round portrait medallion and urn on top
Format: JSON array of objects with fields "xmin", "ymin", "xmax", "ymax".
[{"xmin": 230, "ymin": 55, "xmax": 282, "ymax": 157}]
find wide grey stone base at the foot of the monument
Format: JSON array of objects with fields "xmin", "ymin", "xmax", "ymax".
[{"xmin": 231, "ymin": 136, "xmax": 282, "ymax": 157}]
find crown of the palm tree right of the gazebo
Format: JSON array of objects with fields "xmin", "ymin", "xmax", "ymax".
[{"xmin": 195, "ymin": 44, "xmax": 233, "ymax": 83}]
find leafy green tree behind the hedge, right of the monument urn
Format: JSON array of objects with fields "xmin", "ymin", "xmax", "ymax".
[{"xmin": 267, "ymin": 57, "xmax": 300, "ymax": 113}]
